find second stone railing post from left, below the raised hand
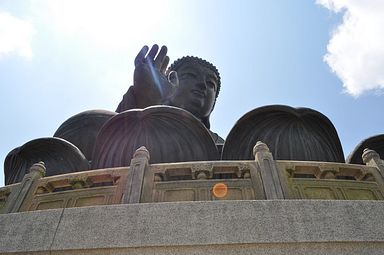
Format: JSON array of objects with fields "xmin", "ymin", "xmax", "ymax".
[{"xmin": 123, "ymin": 146, "xmax": 149, "ymax": 204}]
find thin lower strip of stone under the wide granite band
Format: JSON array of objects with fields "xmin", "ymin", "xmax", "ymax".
[{"xmin": 50, "ymin": 243, "xmax": 384, "ymax": 255}]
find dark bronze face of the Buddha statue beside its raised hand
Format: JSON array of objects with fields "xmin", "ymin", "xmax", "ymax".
[{"xmin": 172, "ymin": 61, "xmax": 218, "ymax": 120}]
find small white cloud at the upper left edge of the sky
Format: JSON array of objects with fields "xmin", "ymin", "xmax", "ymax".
[{"xmin": 0, "ymin": 12, "xmax": 35, "ymax": 58}]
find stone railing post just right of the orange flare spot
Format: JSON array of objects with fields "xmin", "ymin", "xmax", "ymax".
[{"xmin": 253, "ymin": 141, "xmax": 284, "ymax": 199}]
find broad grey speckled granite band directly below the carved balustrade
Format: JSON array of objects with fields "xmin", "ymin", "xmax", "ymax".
[{"xmin": 0, "ymin": 200, "xmax": 384, "ymax": 254}]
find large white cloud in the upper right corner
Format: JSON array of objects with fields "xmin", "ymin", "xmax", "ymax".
[{"xmin": 316, "ymin": 0, "xmax": 384, "ymax": 97}]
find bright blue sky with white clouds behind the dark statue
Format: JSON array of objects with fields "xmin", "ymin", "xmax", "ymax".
[{"xmin": 0, "ymin": 0, "xmax": 384, "ymax": 185}]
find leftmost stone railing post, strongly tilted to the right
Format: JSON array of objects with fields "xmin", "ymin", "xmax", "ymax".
[{"xmin": 5, "ymin": 161, "xmax": 46, "ymax": 213}]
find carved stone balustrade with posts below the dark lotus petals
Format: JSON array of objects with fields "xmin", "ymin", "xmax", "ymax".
[{"xmin": 0, "ymin": 142, "xmax": 384, "ymax": 213}]
